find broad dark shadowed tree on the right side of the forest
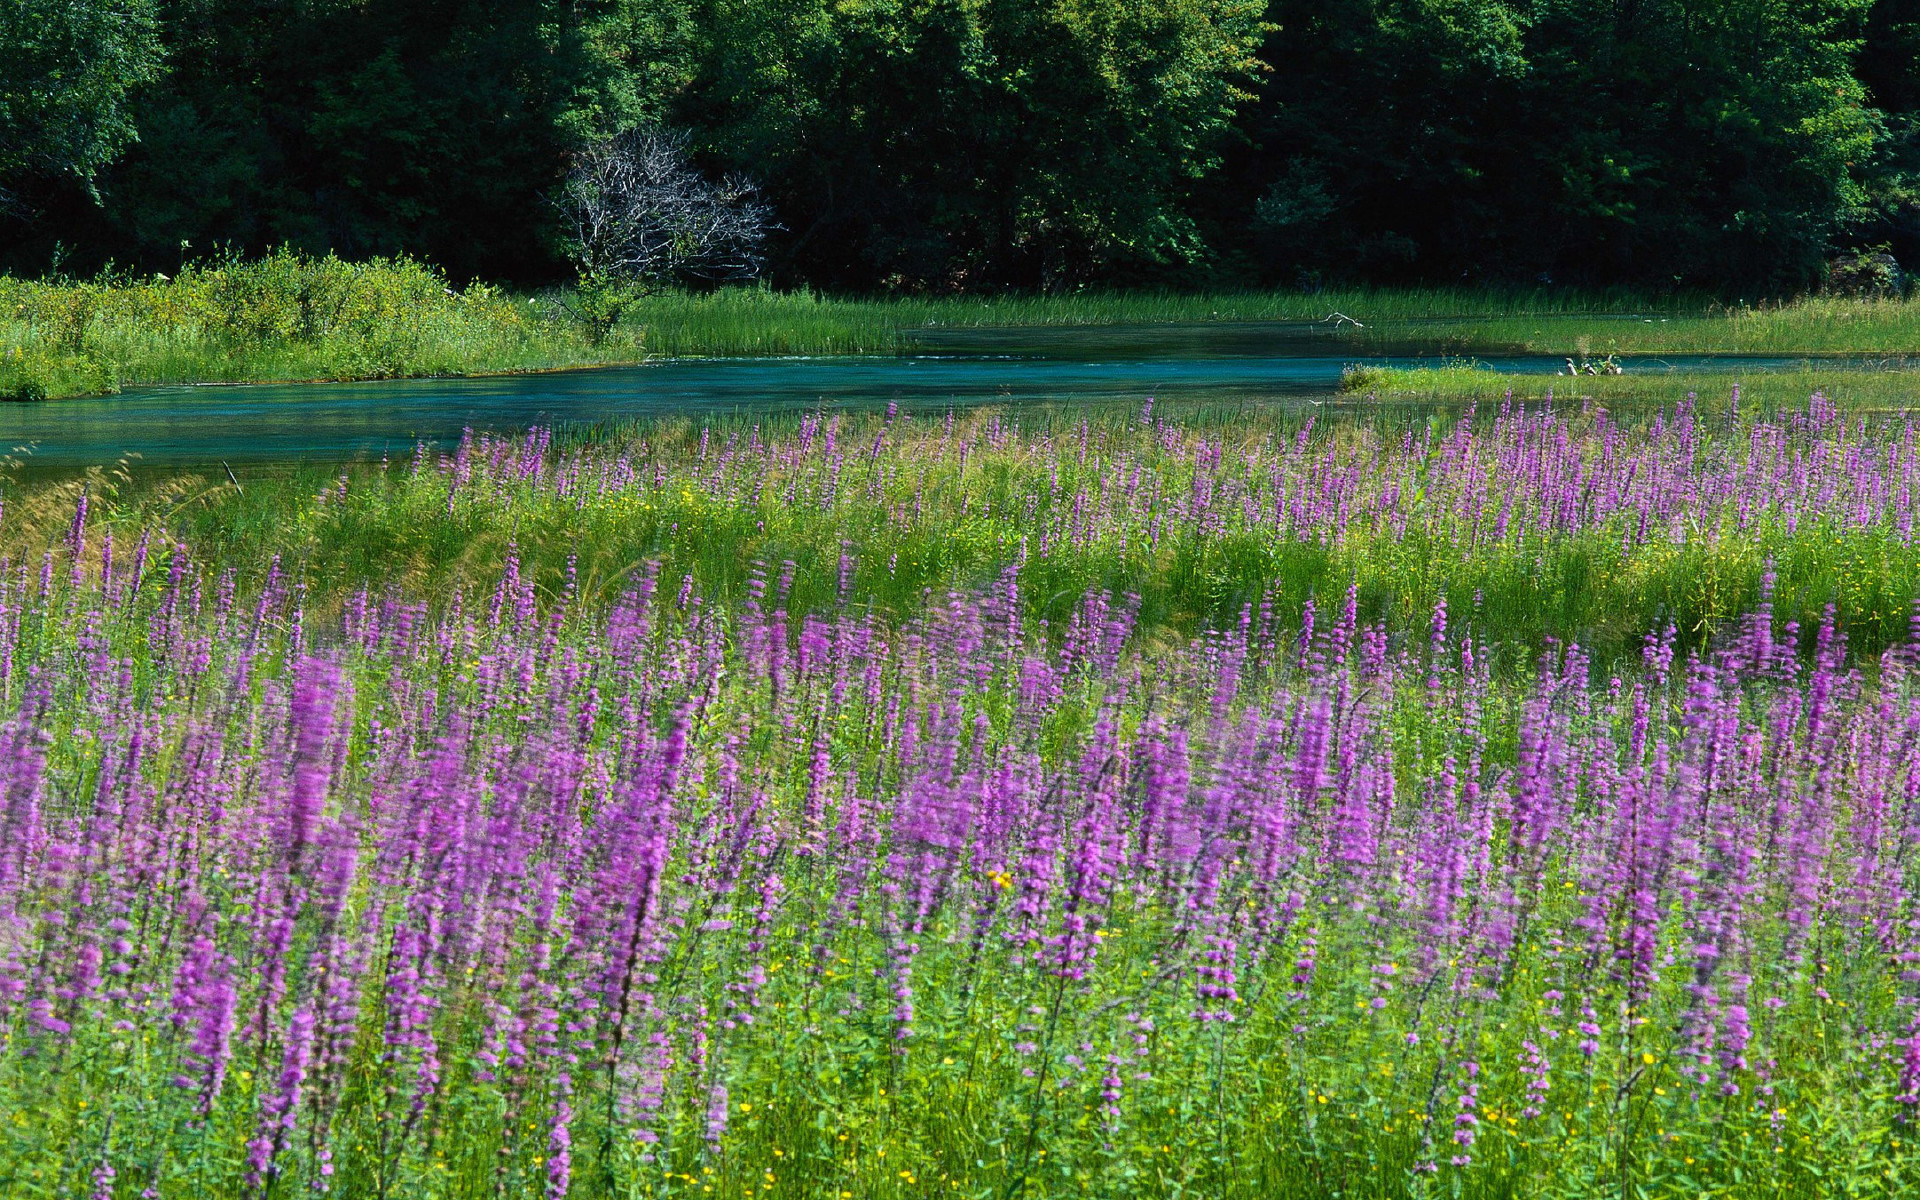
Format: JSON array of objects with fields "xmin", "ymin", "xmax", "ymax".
[{"xmin": 1248, "ymin": 0, "xmax": 1874, "ymax": 290}]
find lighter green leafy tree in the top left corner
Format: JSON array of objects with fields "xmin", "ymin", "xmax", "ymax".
[{"xmin": 0, "ymin": 0, "xmax": 161, "ymax": 198}]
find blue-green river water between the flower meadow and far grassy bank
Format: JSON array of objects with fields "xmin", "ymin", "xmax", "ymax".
[{"xmin": 0, "ymin": 324, "xmax": 1858, "ymax": 468}]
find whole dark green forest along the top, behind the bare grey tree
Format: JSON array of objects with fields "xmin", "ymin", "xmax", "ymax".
[{"xmin": 11, "ymin": 0, "xmax": 1920, "ymax": 291}]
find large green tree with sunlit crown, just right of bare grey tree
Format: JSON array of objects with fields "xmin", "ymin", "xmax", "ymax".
[{"xmin": 678, "ymin": 0, "xmax": 1261, "ymax": 286}]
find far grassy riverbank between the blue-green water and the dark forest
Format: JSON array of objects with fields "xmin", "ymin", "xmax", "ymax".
[{"xmin": 11, "ymin": 253, "xmax": 1920, "ymax": 399}]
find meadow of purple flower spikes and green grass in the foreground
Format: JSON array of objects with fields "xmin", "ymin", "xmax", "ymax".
[{"xmin": 0, "ymin": 399, "xmax": 1920, "ymax": 1200}]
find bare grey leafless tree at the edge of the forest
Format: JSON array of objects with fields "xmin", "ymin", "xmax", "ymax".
[{"xmin": 559, "ymin": 129, "xmax": 774, "ymax": 286}]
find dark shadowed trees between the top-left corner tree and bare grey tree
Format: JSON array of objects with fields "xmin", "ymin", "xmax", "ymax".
[{"xmin": 3, "ymin": 0, "xmax": 685, "ymax": 276}]
